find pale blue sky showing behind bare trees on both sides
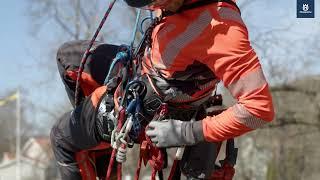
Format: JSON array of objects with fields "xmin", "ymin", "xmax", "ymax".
[{"xmin": 0, "ymin": 0, "xmax": 320, "ymax": 132}]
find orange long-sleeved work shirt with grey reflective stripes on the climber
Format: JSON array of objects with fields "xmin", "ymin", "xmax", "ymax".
[{"xmin": 143, "ymin": 3, "xmax": 274, "ymax": 142}]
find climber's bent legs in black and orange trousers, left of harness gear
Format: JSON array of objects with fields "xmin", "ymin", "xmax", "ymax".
[{"xmin": 50, "ymin": 41, "xmax": 119, "ymax": 180}]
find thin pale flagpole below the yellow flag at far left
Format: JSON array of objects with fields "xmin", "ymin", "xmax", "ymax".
[{"xmin": 16, "ymin": 89, "xmax": 21, "ymax": 180}]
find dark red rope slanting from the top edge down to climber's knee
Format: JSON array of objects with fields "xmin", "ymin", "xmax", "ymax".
[{"xmin": 75, "ymin": 0, "xmax": 117, "ymax": 106}]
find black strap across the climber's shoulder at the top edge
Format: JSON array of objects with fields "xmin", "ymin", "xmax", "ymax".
[{"xmin": 162, "ymin": 0, "xmax": 241, "ymax": 17}]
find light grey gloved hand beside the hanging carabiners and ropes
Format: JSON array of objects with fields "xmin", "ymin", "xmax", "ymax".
[{"xmin": 146, "ymin": 119, "xmax": 204, "ymax": 148}]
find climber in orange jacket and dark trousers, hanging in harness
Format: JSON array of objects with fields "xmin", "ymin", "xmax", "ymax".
[{"xmin": 51, "ymin": 0, "xmax": 274, "ymax": 179}]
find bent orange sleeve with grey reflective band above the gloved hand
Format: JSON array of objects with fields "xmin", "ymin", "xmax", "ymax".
[{"xmin": 202, "ymin": 16, "xmax": 274, "ymax": 142}]
